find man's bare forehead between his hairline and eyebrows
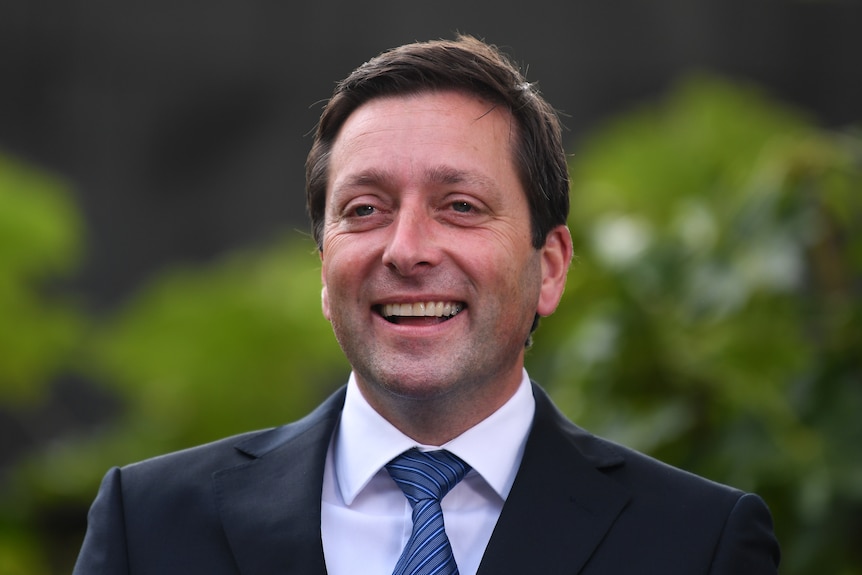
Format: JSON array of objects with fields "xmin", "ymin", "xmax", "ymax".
[{"xmin": 330, "ymin": 92, "xmax": 516, "ymax": 191}]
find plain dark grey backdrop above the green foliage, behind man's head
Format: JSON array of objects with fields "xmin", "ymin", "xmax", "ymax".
[{"xmin": 0, "ymin": 0, "xmax": 862, "ymax": 308}]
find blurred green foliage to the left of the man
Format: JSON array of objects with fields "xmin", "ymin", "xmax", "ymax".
[{"xmin": 0, "ymin": 153, "xmax": 349, "ymax": 575}]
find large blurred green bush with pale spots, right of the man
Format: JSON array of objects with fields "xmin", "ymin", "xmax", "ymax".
[{"xmin": 529, "ymin": 77, "xmax": 862, "ymax": 574}]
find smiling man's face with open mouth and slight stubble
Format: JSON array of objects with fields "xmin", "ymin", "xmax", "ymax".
[{"xmin": 321, "ymin": 92, "xmax": 570, "ymax": 414}]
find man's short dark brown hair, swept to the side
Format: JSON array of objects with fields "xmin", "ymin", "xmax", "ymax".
[{"xmin": 305, "ymin": 36, "xmax": 569, "ymax": 249}]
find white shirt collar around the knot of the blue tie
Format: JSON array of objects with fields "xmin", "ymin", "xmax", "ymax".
[{"xmin": 333, "ymin": 370, "xmax": 536, "ymax": 505}]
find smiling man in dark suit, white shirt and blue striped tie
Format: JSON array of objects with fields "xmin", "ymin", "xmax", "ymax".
[{"xmin": 75, "ymin": 37, "xmax": 779, "ymax": 575}]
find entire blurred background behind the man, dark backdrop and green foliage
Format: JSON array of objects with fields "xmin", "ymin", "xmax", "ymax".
[{"xmin": 0, "ymin": 0, "xmax": 862, "ymax": 575}]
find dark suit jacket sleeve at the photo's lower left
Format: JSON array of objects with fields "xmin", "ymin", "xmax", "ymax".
[{"xmin": 72, "ymin": 467, "xmax": 129, "ymax": 575}]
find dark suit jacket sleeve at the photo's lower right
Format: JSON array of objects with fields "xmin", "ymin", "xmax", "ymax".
[{"xmin": 709, "ymin": 493, "xmax": 781, "ymax": 575}]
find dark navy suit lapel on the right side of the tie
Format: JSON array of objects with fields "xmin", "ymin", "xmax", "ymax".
[{"xmin": 478, "ymin": 385, "xmax": 630, "ymax": 575}]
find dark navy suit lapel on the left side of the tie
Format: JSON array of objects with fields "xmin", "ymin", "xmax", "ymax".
[{"xmin": 213, "ymin": 390, "xmax": 344, "ymax": 575}]
